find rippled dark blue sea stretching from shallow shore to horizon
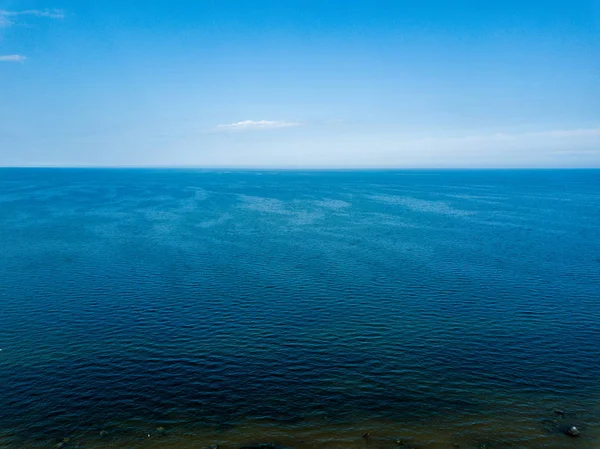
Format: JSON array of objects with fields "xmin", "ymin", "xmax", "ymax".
[{"xmin": 0, "ymin": 169, "xmax": 600, "ymax": 448}]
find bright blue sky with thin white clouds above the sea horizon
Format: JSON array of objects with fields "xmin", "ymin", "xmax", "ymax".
[{"xmin": 0, "ymin": 0, "xmax": 600, "ymax": 168}]
